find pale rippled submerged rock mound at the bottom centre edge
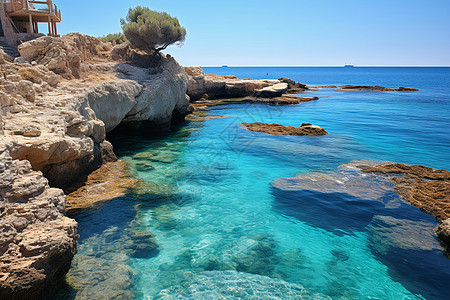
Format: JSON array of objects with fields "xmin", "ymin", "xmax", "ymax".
[{"xmin": 157, "ymin": 271, "xmax": 331, "ymax": 299}]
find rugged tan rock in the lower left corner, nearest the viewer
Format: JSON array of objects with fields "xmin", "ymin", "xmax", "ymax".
[{"xmin": 0, "ymin": 142, "xmax": 78, "ymax": 299}]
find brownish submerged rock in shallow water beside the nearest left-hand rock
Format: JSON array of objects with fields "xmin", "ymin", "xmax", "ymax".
[{"xmin": 61, "ymin": 223, "xmax": 159, "ymax": 299}]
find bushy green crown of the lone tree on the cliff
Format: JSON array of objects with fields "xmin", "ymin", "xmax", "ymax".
[{"xmin": 120, "ymin": 6, "xmax": 186, "ymax": 53}]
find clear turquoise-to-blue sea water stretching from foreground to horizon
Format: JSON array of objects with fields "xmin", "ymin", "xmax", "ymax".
[{"xmin": 64, "ymin": 68, "xmax": 450, "ymax": 299}]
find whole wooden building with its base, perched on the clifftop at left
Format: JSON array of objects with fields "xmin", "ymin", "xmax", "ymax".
[{"xmin": 0, "ymin": 0, "xmax": 61, "ymax": 47}]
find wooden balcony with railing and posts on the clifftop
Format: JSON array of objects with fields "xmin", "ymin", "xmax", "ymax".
[{"xmin": 0, "ymin": 0, "xmax": 61, "ymax": 36}]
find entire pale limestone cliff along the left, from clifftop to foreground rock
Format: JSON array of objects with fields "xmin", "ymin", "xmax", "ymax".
[{"xmin": 0, "ymin": 34, "xmax": 189, "ymax": 299}]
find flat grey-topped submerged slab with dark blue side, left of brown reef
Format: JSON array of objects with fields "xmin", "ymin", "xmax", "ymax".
[{"xmin": 272, "ymin": 164, "xmax": 434, "ymax": 234}]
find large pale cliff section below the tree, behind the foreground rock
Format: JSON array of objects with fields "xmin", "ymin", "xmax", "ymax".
[{"xmin": 0, "ymin": 34, "xmax": 189, "ymax": 186}]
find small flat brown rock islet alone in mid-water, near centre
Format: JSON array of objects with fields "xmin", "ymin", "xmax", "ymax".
[{"xmin": 241, "ymin": 122, "xmax": 328, "ymax": 136}]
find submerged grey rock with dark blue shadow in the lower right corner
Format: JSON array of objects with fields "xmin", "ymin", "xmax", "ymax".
[{"xmin": 368, "ymin": 216, "xmax": 450, "ymax": 299}]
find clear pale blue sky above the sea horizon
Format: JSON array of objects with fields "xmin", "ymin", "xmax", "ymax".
[{"xmin": 54, "ymin": 0, "xmax": 450, "ymax": 66}]
